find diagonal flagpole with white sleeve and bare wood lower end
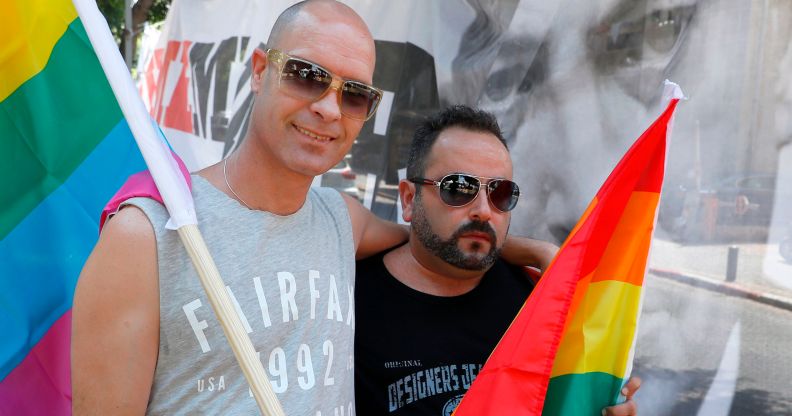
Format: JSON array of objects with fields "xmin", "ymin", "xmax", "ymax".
[{"xmin": 73, "ymin": 0, "xmax": 284, "ymax": 416}]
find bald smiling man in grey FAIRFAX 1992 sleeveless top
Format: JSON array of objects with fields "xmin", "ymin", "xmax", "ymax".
[{"xmin": 72, "ymin": 1, "xmax": 407, "ymax": 415}]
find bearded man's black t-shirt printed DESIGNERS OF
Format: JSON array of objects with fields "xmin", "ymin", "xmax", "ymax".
[{"xmin": 355, "ymin": 253, "xmax": 533, "ymax": 416}]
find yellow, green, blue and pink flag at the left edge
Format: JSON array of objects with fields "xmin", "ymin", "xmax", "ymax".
[{"xmin": 0, "ymin": 0, "xmax": 145, "ymax": 415}]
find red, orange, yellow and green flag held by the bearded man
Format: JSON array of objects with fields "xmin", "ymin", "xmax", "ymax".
[{"xmin": 454, "ymin": 84, "xmax": 681, "ymax": 416}]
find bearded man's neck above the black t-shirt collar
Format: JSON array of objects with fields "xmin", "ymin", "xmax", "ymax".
[{"xmin": 383, "ymin": 242, "xmax": 485, "ymax": 297}]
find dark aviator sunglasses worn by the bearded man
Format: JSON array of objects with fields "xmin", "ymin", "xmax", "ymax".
[{"xmin": 409, "ymin": 173, "xmax": 520, "ymax": 212}]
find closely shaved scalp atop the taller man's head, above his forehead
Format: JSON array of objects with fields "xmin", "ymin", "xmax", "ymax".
[{"xmin": 267, "ymin": 0, "xmax": 373, "ymax": 48}]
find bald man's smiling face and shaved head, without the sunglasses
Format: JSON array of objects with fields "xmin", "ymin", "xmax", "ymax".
[{"xmin": 243, "ymin": 0, "xmax": 376, "ymax": 179}]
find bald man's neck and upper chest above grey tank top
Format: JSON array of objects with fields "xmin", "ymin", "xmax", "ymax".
[{"xmin": 198, "ymin": 140, "xmax": 313, "ymax": 215}]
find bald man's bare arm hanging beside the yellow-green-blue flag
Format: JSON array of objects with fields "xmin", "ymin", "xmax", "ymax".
[{"xmin": 71, "ymin": 207, "xmax": 159, "ymax": 415}]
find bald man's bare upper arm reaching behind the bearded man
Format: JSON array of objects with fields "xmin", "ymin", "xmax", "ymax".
[{"xmin": 341, "ymin": 193, "xmax": 410, "ymax": 260}]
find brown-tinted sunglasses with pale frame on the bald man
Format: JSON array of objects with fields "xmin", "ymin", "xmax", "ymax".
[{"xmin": 267, "ymin": 49, "xmax": 382, "ymax": 121}]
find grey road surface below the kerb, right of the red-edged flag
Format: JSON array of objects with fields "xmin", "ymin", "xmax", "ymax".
[{"xmin": 633, "ymin": 275, "xmax": 792, "ymax": 416}]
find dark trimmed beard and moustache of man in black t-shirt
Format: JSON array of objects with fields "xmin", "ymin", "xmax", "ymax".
[{"xmin": 412, "ymin": 203, "xmax": 500, "ymax": 271}]
